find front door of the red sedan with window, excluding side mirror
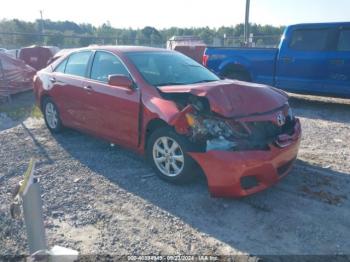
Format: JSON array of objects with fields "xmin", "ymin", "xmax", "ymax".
[{"xmin": 85, "ymin": 51, "xmax": 140, "ymax": 147}]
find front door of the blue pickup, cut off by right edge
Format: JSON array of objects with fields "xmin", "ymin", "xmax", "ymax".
[{"xmin": 327, "ymin": 27, "xmax": 350, "ymax": 96}]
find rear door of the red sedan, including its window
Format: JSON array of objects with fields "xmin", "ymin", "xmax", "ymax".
[{"xmin": 49, "ymin": 51, "xmax": 92, "ymax": 129}]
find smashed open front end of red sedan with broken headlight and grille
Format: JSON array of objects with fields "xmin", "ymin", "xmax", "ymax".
[{"xmin": 164, "ymin": 93, "xmax": 295, "ymax": 151}]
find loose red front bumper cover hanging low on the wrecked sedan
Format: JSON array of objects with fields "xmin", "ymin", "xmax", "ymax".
[{"xmin": 189, "ymin": 119, "xmax": 301, "ymax": 197}]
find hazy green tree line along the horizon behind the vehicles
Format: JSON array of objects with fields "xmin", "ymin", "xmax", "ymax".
[{"xmin": 0, "ymin": 19, "xmax": 284, "ymax": 48}]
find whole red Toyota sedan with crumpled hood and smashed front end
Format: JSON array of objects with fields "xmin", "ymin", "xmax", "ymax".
[{"xmin": 34, "ymin": 46, "xmax": 301, "ymax": 197}]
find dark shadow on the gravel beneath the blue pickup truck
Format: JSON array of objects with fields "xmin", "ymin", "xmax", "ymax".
[{"xmin": 289, "ymin": 94, "xmax": 350, "ymax": 124}]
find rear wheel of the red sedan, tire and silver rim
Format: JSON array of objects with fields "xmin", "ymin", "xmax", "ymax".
[{"xmin": 42, "ymin": 97, "xmax": 63, "ymax": 133}]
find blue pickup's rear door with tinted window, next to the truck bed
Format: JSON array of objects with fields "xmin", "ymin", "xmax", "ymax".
[{"xmin": 276, "ymin": 28, "xmax": 331, "ymax": 93}]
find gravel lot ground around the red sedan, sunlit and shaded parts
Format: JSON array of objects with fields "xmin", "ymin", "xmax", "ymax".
[{"xmin": 0, "ymin": 93, "xmax": 350, "ymax": 255}]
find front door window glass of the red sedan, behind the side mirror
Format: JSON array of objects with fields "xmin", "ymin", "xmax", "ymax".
[{"xmin": 91, "ymin": 51, "xmax": 129, "ymax": 83}]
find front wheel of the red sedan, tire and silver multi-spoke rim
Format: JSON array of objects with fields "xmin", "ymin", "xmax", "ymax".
[{"xmin": 146, "ymin": 127, "xmax": 199, "ymax": 184}]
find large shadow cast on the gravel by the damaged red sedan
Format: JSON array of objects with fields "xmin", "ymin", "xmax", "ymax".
[{"xmin": 55, "ymin": 130, "xmax": 350, "ymax": 255}]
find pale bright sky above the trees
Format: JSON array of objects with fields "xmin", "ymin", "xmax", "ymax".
[{"xmin": 0, "ymin": 0, "xmax": 350, "ymax": 29}]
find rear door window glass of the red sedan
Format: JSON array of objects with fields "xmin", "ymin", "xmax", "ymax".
[{"xmin": 65, "ymin": 51, "xmax": 91, "ymax": 77}]
